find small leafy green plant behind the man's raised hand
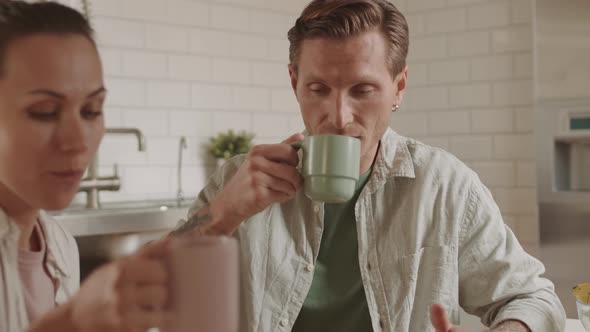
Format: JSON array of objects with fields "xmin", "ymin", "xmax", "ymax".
[{"xmin": 209, "ymin": 129, "xmax": 254, "ymax": 166}]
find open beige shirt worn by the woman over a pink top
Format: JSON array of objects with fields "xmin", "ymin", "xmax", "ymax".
[{"xmin": 0, "ymin": 209, "xmax": 80, "ymax": 332}]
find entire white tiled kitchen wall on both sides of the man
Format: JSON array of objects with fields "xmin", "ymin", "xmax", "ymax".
[{"xmin": 64, "ymin": 0, "xmax": 538, "ymax": 245}]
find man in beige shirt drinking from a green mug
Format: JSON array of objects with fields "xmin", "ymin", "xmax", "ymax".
[{"xmin": 177, "ymin": 0, "xmax": 565, "ymax": 332}]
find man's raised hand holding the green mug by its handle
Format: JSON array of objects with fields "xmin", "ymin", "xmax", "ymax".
[{"xmin": 208, "ymin": 134, "xmax": 303, "ymax": 235}]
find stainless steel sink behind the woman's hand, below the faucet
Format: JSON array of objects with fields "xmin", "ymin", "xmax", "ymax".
[{"xmin": 52, "ymin": 203, "xmax": 193, "ymax": 279}]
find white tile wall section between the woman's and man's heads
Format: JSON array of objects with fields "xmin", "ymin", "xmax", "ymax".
[{"xmin": 63, "ymin": 0, "xmax": 306, "ymax": 202}]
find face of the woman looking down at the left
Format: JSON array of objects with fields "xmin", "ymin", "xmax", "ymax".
[{"xmin": 0, "ymin": 34, "xmax": 106, "ymax": 210}]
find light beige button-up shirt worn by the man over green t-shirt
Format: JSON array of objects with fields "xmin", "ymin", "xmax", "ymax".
[{"xmin": 179, "ymin": 130, "xmax": 565, "ymax": 332}]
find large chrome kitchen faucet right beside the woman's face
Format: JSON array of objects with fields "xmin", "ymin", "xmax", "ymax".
[{"xmin": 78, "ymin": 128, "xmax": 146, "ymax": 209}]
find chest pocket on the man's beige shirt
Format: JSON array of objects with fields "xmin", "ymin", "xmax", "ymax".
[{"xmin": 399, "ymin": 246, "xmax": 459, "ymax": 331}]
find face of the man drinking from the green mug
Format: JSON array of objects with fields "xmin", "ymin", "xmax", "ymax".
[{"xmin": 289, "ymin": 31, "xmax": 407, "ymax": 172}]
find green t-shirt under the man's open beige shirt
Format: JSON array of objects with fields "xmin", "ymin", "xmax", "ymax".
[{"xmin": 292, "ymin": 170, "xmax": 373, "ymax": 332}]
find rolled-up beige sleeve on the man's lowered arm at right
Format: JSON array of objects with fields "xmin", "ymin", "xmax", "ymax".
[{"xmin": 459, "ymin": 178, "xmax": 565, "ymax": 332}]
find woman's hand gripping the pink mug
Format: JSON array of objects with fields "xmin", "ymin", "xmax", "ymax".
[{"xmin": 71, "ymin": 240, "xmax": 169, "ymax": 332}]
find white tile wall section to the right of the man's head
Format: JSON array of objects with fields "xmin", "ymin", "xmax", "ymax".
[{"xmin": 391, "ymin": 0, "xmax": 538, "ymax": 246}]
